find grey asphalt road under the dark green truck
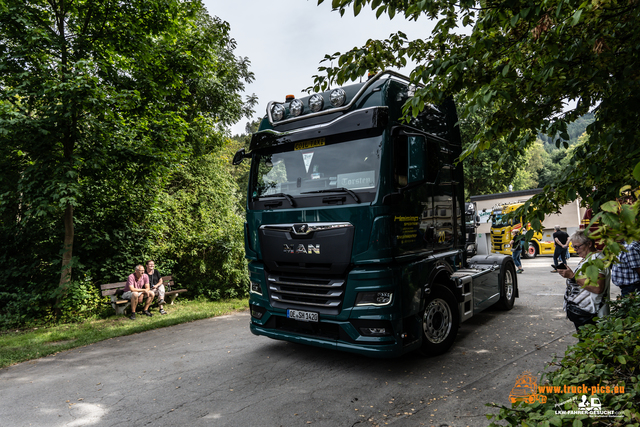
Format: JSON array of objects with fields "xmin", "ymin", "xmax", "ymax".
[{"xmin": 0, "ymin": 257, "xmax": 618, "ymax": 427}]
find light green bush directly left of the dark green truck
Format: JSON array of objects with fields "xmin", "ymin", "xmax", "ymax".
[{"xmin": 152, "ymin": 149, "xmax": 249, "ymax": 299}]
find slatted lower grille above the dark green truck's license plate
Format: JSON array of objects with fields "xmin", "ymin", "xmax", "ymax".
[{"xmin": 267, "ymin": 274, "xmax": 345, "ymax": 314}]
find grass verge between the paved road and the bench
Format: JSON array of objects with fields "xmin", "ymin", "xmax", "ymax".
[{"xmin": 0, "ymin": 299, "xmax": 249, "ymax": 369}]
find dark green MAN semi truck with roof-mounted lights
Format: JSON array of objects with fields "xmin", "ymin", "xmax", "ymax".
[{"xmin": 234, "ymin": 71, "xmax": 518, "ymax": 357}]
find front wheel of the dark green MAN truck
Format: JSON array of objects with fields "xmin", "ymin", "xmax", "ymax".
[{"xmin": 419, "ymin": 285, "xmax": 460, "ymax": 356}]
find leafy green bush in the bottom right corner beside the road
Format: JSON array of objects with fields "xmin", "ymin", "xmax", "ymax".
[{"xmin": 487, "ymin": 294, "xmax": 640, "ymax": 426}]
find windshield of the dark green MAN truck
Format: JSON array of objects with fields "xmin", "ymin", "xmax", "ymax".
[{"xmin": 251, "ymin": 137, "xmax": 382, "ymax": 198}]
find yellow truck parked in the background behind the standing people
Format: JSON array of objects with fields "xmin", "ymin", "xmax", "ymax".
[{"xmin": 491, "ymin": 202, "xmax": 579, "ymax": 258}]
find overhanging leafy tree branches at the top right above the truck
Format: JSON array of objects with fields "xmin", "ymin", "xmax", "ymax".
[{"xmin": 310, "ymin": 0, "xmax": 640, "ymax": 213}]
